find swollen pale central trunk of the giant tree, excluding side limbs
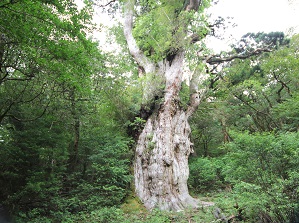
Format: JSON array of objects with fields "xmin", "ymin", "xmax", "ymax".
[{"xmin": 134, "ymin": 53, "xmax": 204, "ymax": 210}]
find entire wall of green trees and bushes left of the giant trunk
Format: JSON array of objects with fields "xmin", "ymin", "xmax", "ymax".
[{"xmin": 0, "ymin": 1, "xmax": 131, "ymax": 222}]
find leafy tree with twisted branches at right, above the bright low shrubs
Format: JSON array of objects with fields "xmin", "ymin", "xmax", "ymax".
[{"xmin": 211, "ymin": 33, "xmax": 298, "ymax": 132}]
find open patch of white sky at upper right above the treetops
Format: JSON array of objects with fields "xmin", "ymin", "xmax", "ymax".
[{"xmin": 208, "ymin": 0, "xmax": 299, "ymax": 51}]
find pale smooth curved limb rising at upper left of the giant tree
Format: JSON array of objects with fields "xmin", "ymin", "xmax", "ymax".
[{"xmin": 124, "ymin": 0, "xmax": 155, "ymax": 73}]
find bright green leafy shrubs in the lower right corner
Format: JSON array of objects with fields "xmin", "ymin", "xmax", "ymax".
[{"xmin": 218, "ymin": 133, "xmax": 299, "ymax": 222}]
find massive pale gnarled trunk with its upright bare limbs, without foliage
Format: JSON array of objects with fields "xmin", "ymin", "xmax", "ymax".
[{"xmin": 124, "ymin": 0, "xmax": 210, "ymax": 210}]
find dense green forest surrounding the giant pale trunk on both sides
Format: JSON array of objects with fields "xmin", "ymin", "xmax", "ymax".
[{"xmin": 0, "ymin": 0, "xmax": 299, "ymax": 223}]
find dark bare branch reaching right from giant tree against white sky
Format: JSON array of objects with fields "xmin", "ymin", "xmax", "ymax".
[{"xmin": 206, "ymin": 48, "xmax": 271, "ymax": 65}]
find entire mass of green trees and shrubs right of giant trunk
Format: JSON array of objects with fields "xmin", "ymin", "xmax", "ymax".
[{"xmin": 188, "ymin": 33, "xmax": 299, "ymax": 222}]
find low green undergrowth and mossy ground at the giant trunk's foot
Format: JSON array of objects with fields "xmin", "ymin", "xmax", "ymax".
[{"xmin": 121, "ymin": 191, "xmax": 244, "ymax": 223}]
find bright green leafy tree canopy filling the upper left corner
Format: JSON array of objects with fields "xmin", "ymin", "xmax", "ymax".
[{"xmin": 0, "ymin": 0, "xmax": 99, "ymax": 122}]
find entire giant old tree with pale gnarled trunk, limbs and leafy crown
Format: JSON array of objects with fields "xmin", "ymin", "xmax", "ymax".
[{"xmin": 105, "ymin": 0, "xmax": 268, "ymax": 210}]
